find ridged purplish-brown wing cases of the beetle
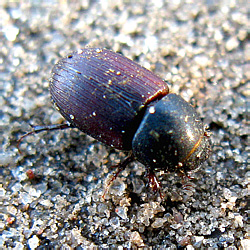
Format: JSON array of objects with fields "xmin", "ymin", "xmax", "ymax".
[{"xmin": 50, "ymin": 48, "xmax": 169, "ymax": 150}]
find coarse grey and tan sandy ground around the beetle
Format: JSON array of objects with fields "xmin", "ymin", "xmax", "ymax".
[{"xmin": 0, "ymin": 0, "xmax": 250, "ymax": 249}]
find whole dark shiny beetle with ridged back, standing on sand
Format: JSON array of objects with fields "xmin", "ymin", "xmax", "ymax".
[{"xmin": 19, "ymin": 48, "xmax": 211, "ymax": 195}]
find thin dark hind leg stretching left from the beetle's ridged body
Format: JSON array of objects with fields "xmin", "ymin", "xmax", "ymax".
[{"xmin": 17, "ymin": 123, "xmax": 74, "ymax": 154}]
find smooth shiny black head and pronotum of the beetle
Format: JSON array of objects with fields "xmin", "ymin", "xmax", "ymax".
[{"xmin": 132, "ymin": 94, "xmax": 210, "ymax": 172}]
